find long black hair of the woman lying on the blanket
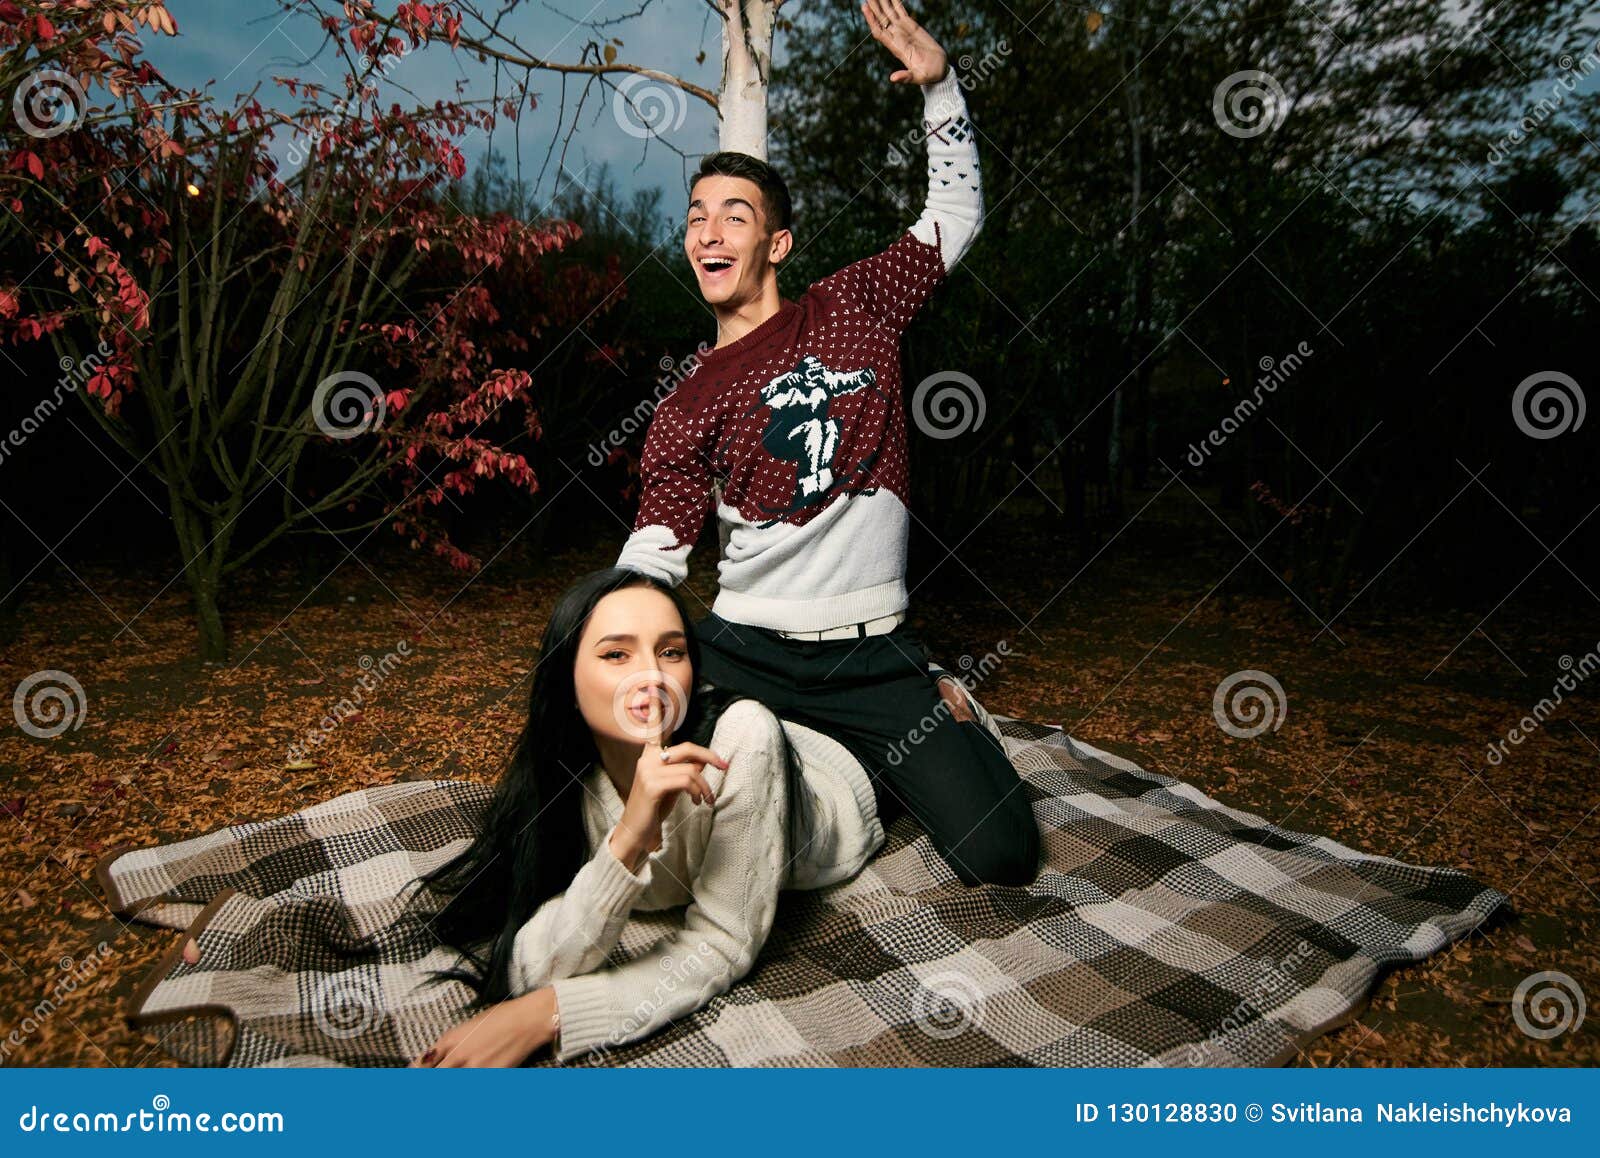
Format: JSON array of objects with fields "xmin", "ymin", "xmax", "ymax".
[{"xmin": 411, "ymin": 568, "xmax": 811, "ymax": 1006}]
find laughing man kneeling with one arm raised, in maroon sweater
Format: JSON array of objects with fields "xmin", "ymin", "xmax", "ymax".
[{"xmin": 618, "ymin": 0, "xmax": 1038, "ymax": 884}]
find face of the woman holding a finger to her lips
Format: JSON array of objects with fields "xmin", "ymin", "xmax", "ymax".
[{"xmin": 573, "ymin": 587, "xmax": 694, "ymax": 744}]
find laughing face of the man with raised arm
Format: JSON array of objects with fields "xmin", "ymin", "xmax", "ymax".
[{"xmin": 683, "ymin": 174, "xmax": 790, "ymax": 305}]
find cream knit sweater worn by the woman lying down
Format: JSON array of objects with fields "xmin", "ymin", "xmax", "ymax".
[{"xmin": 510, "ymin": 699, "xmax": 883, "ymax": 1060}]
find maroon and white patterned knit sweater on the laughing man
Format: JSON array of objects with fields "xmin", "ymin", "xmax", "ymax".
[{"xmin": 618, "ymin": 69, "xmax": 982, "ymax": 632}]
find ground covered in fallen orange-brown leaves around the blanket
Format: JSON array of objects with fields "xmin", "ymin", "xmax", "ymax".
[{"xmin": 0, "ymin": 496, "xmax": 1600, "ymax": 1065}]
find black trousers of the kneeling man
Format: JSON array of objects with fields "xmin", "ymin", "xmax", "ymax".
[{"xmin": 694, "ymin": 613, "xmax": 1038, "ymax": 884}]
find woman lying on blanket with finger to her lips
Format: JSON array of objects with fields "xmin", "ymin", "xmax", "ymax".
[{"xmin": 416, "ymin": 568, "xmax": 883, "ymax": 1067}]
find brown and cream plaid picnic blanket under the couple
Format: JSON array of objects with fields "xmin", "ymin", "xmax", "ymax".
[{"xmin": 99, "ymin": 715, "xmax": 1507, "ymax": 1067}]
